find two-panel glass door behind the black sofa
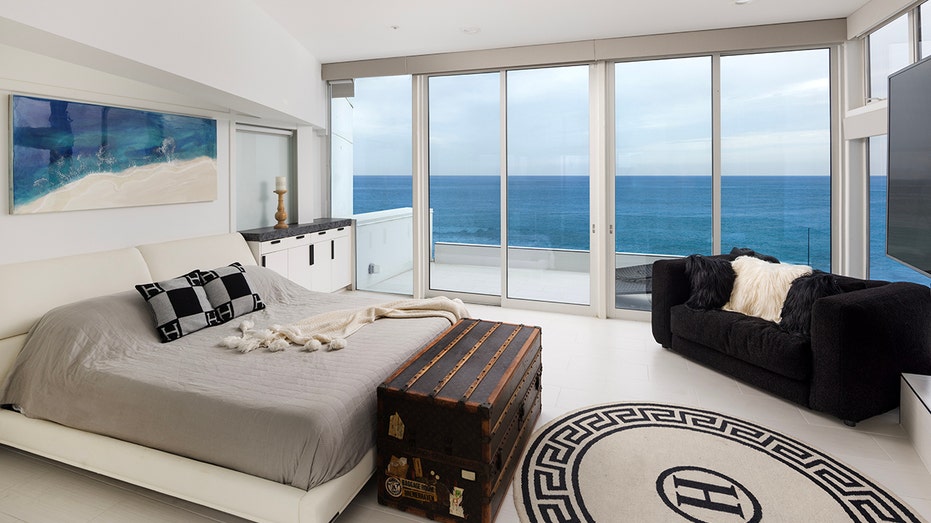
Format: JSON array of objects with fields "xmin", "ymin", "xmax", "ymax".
[{"xmin": 609, "ymin": 49, "xmax": 831, "ymax": 310}]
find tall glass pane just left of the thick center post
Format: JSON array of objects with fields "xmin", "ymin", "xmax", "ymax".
[{"xmin": 507, "ymin": 66, "xmax": 590, "ymax": 305}]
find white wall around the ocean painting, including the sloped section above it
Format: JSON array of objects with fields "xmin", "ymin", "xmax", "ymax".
[{"xmin": 0, "ymin": 0, "xmax": 336, "ymax": 263}]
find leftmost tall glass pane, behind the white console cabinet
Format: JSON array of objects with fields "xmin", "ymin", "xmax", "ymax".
[{"xmin": 330, "ymin": 76, "xmax": 414, "ymax": 295}]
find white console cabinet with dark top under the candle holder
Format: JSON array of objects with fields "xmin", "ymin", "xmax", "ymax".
[{"xmin": 242, "ymin": 220, "xmax": 353, "ymax": 292}]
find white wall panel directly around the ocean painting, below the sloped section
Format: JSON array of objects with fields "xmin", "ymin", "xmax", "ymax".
[{"xmin": 0, "ymin": 45, "xmax": 237, "ymax": 264}]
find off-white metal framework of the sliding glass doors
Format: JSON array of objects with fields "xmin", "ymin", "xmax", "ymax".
[{"xmin": 412, "ymin": 45, "xmax": 844, "ymax": 321}]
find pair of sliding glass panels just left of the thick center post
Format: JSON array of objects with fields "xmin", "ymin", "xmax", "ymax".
[{"xmin": 428, "ymin": 66, "xmax": 591, "ymax": 305}]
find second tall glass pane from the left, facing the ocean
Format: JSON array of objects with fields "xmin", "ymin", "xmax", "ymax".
[{"xmin": 429, "ymin": 73, "xmax": 501, "ymax": 296}]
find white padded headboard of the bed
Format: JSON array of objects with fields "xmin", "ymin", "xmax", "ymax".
[{"xmin": 0, "ymin": 233, "xmax": 255, "ymax": 383}]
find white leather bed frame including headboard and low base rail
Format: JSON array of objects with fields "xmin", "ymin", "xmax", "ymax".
[{"xmin": 0, "ymin": 233, "xmax": 375, "ymax": 523}]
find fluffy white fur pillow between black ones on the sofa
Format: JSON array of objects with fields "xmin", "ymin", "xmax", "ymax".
[{"xmin": 723, "ymin": 256, "xmax": 811, "ymax": 323}]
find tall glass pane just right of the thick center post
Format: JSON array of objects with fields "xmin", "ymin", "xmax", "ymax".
[{"xmin": 614, "ymin": 57, "xmax": 712, "ymax": 310}]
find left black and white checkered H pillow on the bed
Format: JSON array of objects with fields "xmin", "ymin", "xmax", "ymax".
[{"xmin": 136, "ymin": 271, "xmax": 221, "ymax": 342}]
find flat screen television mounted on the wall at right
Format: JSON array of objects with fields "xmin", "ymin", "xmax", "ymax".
[{"xmin": 886, "ymin": 57, "xmax": 931, "ymax": 276}]
